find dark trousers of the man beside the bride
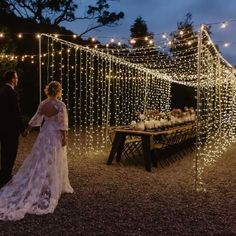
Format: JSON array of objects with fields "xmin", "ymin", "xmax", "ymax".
[{"xmin": 0, "ymin": 131, "xmax": 19, "ymax": 187}]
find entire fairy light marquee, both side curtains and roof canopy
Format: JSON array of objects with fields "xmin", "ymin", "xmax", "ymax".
[{"xmin": 40, "ymin": 28, "xmax": 236, "ymax": 192}]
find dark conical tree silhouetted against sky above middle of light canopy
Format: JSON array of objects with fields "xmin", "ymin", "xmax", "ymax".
[{"xmin": 130, "ymin": 17, "xmax": 154, "ymax": 47}]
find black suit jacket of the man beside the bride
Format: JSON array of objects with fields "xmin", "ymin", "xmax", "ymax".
[{"xmin": 0, "ymin": 85, "xmax": 22, "ymax": 134}]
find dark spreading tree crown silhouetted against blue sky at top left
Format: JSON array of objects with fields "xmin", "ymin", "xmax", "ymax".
[{"xmin": 0, "ymin": 0, "xmax": 124, "ymax": 35}]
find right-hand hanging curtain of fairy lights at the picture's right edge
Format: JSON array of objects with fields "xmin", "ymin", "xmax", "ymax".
[{"xmin": 194, "ymin": 27, "xmax": 236, "ymax": 190}]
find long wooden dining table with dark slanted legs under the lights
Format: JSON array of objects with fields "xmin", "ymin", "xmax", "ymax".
[{"xmin": 107, "ymin": 123, "xmax": 194, "ymax": 171}]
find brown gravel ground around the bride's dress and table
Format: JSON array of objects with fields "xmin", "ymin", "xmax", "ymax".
[{"xmin": 0, "ymin": 132, "xmax": 236, "ymax": 236}]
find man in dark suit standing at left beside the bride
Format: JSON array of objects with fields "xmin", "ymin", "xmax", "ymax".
[{"xmin": 0, "ymin": 70, "xmax": 22, "ymax": 188}]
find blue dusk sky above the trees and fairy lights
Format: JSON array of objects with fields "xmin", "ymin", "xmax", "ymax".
[{"xmin": 64, "ymin": 0, "xmax": 236, "ymax": 65}]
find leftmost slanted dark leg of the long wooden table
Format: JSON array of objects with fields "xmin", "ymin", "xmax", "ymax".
[{"xmin": 107, "ymin": 133, "xmax": 126, "ymax": 165}]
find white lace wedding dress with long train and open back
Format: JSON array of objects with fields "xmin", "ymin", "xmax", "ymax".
[{"xmin": 0, "ymin": 99, "xmax": 73, "ymax": 220}]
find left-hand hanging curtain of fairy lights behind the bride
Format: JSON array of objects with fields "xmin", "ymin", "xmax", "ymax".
[{"xmin": 40, "ymin": 34, "xmax": 171, "ymax": 152}]
